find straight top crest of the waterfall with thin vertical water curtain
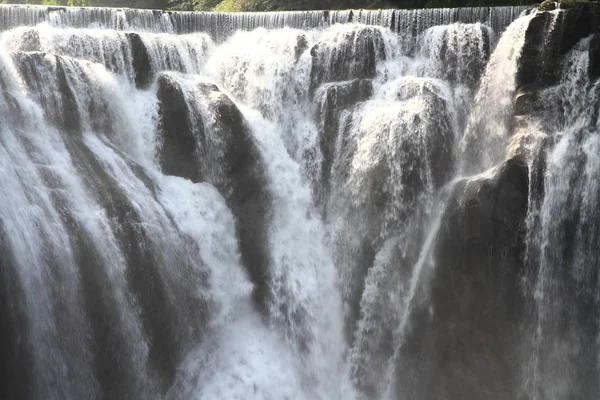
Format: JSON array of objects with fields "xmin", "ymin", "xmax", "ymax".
[{"xmin": 0, "ymin": 4, "xmax": 527, "ymax": 39}]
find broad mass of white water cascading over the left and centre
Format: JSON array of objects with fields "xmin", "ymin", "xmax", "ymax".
[{"xmin": 0, "ymin": 7, "xmax": 576, "ymax": 399}]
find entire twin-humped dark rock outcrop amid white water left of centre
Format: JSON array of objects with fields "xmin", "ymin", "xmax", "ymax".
[{"xmin": 158, "ymin": 75, "xmax": 270, "ymax": 312}]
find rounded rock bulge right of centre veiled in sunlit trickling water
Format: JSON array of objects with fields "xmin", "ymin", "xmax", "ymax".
[{"xmin": 324, "ymin": 77, "xmax": 454, "ymax": 342}]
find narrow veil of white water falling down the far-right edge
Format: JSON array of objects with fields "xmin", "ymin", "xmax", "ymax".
[{"xmin": 525, "ymin": 35, "xmax": 600, "ymax": 400}]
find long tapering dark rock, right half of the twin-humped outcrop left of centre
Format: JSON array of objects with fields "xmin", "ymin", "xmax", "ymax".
[{"xmin": 200, "ymin": 84, "xmax": 271, "ymax": 314}]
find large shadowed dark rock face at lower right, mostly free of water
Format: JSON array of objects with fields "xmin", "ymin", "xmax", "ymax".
[{"xmin": 397, "ymin": 160, "xmax": 528, "ymax": 400}]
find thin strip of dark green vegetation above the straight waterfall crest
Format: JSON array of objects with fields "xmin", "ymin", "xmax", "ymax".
[{"xmin": 3, "ymin": 0, "xmax": 540, "ymax": 11}]
